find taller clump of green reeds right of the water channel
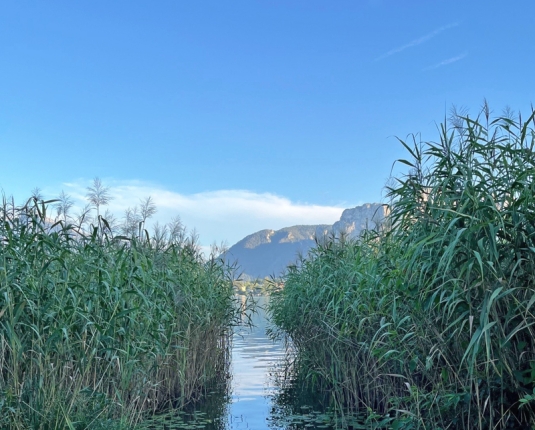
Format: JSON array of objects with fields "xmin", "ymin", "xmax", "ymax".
[{"xmin": 270, "ymin": 103, "xmax": 535, "ymax": 429}]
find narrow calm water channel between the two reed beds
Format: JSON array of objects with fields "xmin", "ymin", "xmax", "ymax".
[{"xmin": 142, "ymin": 297, "xmax": 352, "ymax": 430}]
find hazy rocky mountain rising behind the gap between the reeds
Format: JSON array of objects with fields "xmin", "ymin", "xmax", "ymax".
[{"xmin": 224, "ymin": 203, "xmax": 387, "ymax": 280}]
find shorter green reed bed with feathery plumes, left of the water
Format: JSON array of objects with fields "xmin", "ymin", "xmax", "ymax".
[{"xmin": 0, "ymin": 193, "xmax": 238, "ymax": 429}]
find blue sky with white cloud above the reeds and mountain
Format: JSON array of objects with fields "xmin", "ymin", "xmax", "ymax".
[{"xmin": 0, "ymin": 0, "xmax": 535, "ymax": 245}]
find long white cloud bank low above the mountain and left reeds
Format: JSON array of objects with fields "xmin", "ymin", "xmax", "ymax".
[{"xmin": 56, "ymin": 180, "xmax": 348, "ymax": 247}]
